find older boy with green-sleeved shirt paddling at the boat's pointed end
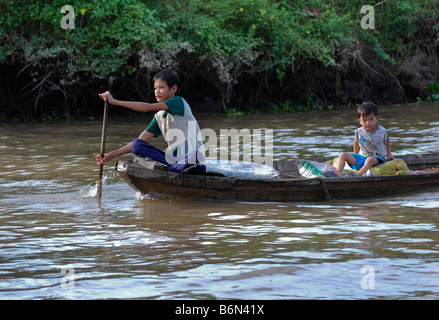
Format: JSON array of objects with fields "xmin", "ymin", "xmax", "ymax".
[{"xmin": 95, "ymin": 70, "xmax": 206, "ymax": 174}]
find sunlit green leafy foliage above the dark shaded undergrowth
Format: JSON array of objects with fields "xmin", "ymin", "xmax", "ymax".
[{"xmin": 0, "ymin": 0, "xmax": 439, "ymax": 119}]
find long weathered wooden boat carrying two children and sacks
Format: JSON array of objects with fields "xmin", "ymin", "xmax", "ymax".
[{"xmin": 116, "ymin": 153, "xmax": 439, "ymax": 202}]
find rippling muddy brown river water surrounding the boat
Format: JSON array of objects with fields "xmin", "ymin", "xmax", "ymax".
[{"xmin": 0, "ymin": 104, "xmax": 439, "ymax": 300}]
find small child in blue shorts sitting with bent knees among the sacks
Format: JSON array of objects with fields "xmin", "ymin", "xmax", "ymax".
[{"xmin": 334, "ymin": 102, "xmax": 394, "ymax": 177}]
